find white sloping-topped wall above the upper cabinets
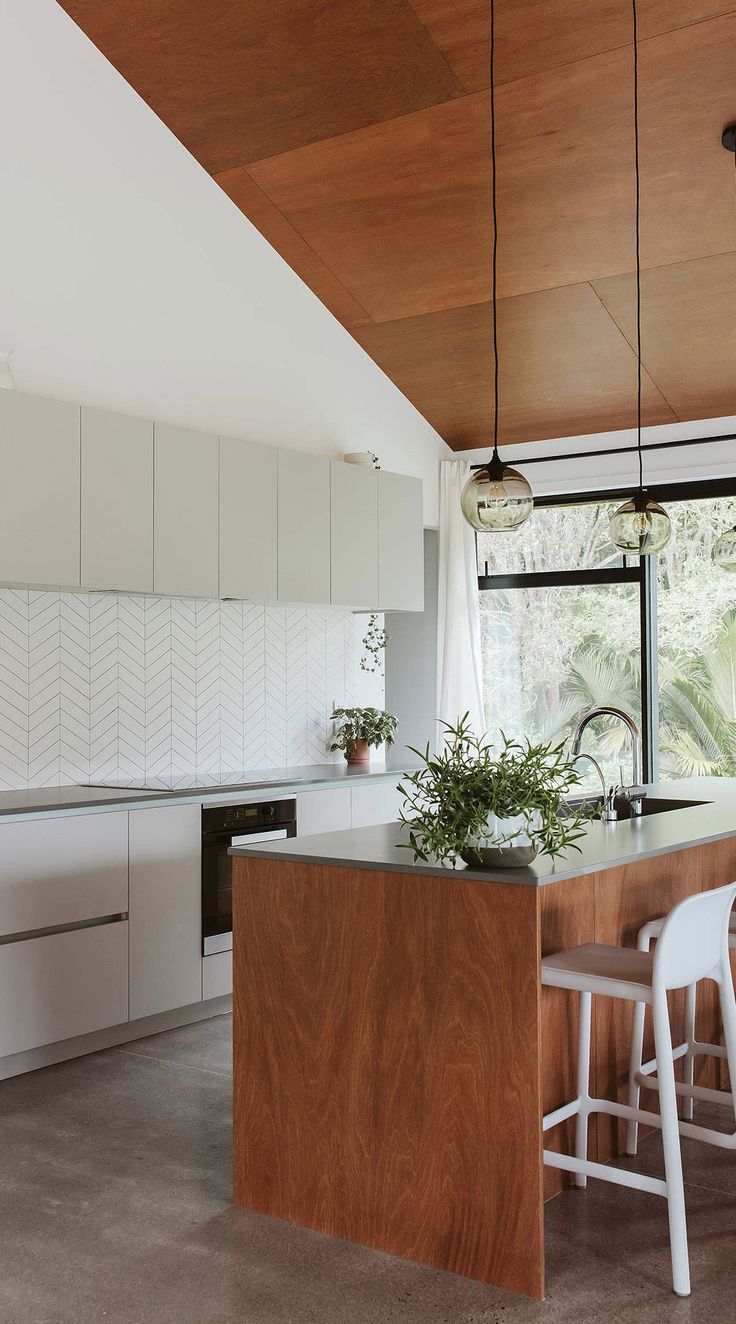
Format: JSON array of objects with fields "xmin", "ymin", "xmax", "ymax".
[{"xmin": 0, "ymin": 0, "xmax": 450, "ymax": 524}]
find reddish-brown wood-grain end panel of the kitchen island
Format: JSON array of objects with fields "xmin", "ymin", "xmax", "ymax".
[{"xmin": 233, "ymin": 858, "xmax": 544, "ymax": 1298}]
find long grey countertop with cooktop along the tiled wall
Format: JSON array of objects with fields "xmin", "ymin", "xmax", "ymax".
[{"xmin": 0, "ymin": 763, "xmax": 401, "ymax": 821}]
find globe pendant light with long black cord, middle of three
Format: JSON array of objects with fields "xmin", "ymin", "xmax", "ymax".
[{"xmin": 610, "ymin": 0, "xmax": 672, "ymax": 556}]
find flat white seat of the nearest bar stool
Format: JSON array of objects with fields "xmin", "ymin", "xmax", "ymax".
[{"xmin": 541, "ymin": 943, "xmax": 654, "ymax": 1002}]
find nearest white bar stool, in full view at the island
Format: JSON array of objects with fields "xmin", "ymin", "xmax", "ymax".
[{"xmin": 541, "ymin": 883, "xmax": 736, "ymax": 1296}]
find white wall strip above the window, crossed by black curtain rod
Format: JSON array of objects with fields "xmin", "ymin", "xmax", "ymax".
[{"xmin": 461, "ymin": 417, "xmax": 736, "ymax": 497}]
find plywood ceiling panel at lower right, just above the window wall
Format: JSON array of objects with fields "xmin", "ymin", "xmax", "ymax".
[{"xmin": 596, "ymin": 253, "xmax": 736, "ymax": 418}]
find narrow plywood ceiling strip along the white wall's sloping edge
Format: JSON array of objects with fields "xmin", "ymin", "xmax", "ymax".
[{"xmin": 214, "ymin": 166, "xmax": 371, "ymax": 328}]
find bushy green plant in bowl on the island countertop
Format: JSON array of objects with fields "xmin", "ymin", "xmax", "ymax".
[{"xmin": 400, "ymin": 714, "xmax": 585, "ymax": 869}]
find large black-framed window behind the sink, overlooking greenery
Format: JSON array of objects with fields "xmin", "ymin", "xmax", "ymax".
[{"xmin": 478, "ymin": 481, "xmax": 736, "ymax": 788}]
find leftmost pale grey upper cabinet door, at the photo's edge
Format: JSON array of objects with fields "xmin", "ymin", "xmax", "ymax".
[{"xmin": 0, "ymin": 391, "xmax": 79, "ymax": 588}]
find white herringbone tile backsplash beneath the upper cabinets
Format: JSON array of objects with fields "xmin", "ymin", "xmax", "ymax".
[{"xmin": 0, "ymin": 589, "xmax": 356, "ymax": 789}]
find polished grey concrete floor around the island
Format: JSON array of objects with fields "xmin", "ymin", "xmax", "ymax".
[{"xmin": 0, "ymin": 1017, "xmax": 736, "ymax": 1324}]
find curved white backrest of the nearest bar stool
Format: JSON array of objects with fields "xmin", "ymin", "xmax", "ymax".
[{"xmin": 653, "ymin": 883, "xmax": 736, "ymax": 989}]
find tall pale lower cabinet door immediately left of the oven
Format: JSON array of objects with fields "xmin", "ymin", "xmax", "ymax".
[{"xmin": 128, "ymin": 805, "xmax": 203, "ymax": 1021}]
